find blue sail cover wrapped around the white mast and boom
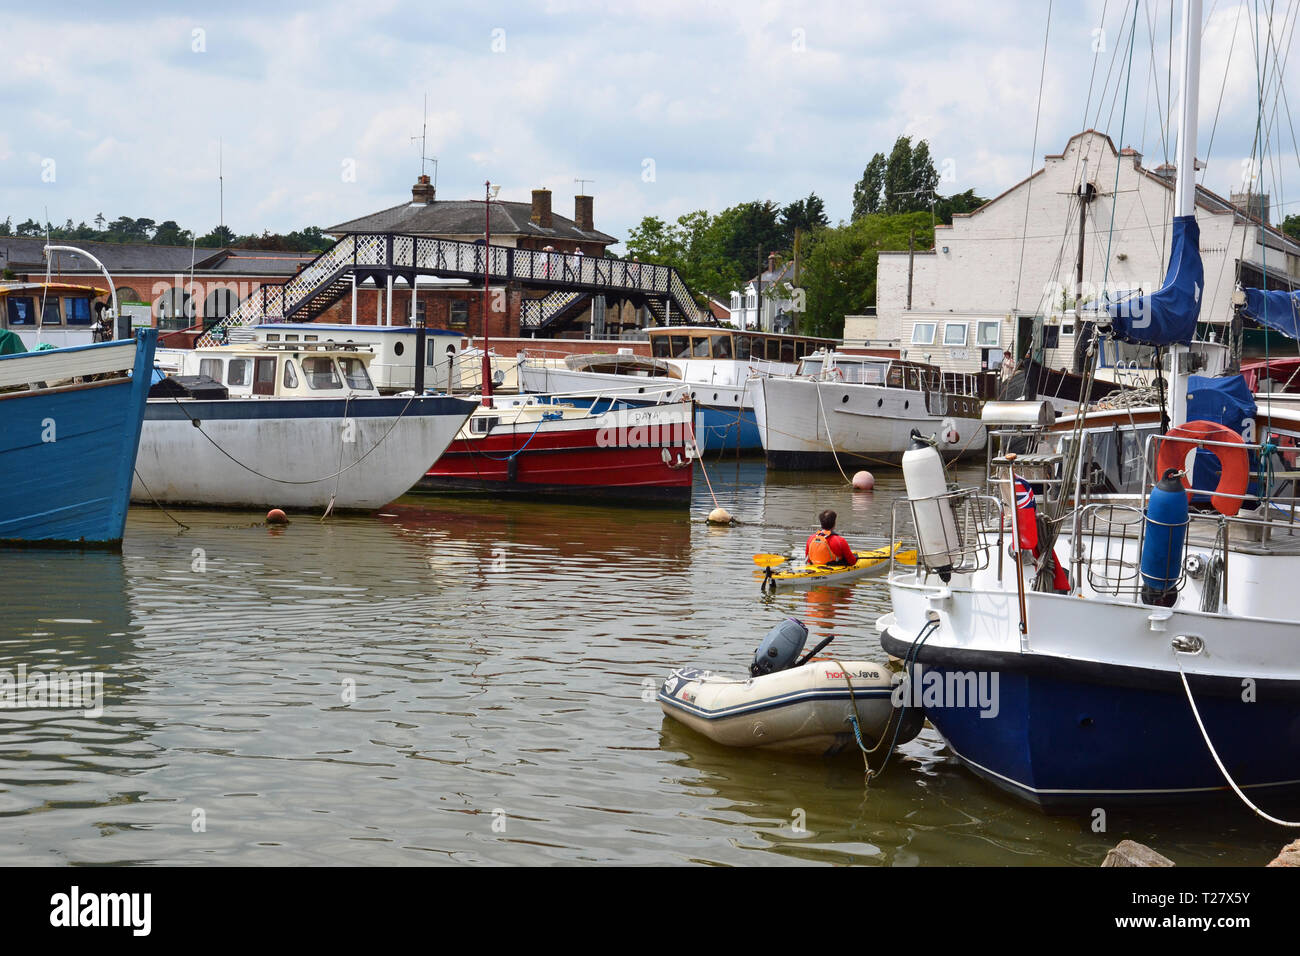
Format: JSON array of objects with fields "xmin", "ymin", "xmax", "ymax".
[{"xmin": 1106, "ymin": 216, "xmax": 1205, "ymax": 345}]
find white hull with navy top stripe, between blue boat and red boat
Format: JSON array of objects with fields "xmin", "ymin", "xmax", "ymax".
[{"xmin": 131, "ymin": 397, "xmax": 475, "ymax": 511}]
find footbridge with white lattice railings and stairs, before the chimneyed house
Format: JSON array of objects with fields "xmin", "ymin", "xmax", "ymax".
[{"xmin": 198, "ymin": 233, "xmax": 714, "ymax": 346}]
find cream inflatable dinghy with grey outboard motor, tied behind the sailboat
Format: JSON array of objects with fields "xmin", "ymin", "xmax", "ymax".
[{"xmin": 658, "ymin": 619, "xmax": 924, "ymax": 756}]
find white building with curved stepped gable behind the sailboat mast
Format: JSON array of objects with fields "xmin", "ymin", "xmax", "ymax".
[{"xmin": 875, "ymin": 130, "xmax": 1300, "ymax": 372}]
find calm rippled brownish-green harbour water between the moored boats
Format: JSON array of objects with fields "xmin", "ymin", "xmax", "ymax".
[{"xmin": 0, "ymin": 462, "xmax": 1284, "ymax": 866}]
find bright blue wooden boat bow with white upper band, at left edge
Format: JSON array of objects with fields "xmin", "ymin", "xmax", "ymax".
[{"xmin": 0, "ymin": 329, "xmax": 157, "ymax": 548}]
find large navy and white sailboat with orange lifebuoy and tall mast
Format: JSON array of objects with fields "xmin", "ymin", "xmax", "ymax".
[{"xmin": 878, "ymin": 0, "xmax": 1300, "ymax": 825}]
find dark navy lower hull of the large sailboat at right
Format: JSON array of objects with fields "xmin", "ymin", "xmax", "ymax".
[{"xmin": 883, "ymin": 636, "xmax": 1300, "ymax": 812}]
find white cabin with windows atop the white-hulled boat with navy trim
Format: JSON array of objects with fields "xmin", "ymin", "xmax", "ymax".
[{"xmin": 155, "ymin": 342, "xmax": 380, "ymax": 398}]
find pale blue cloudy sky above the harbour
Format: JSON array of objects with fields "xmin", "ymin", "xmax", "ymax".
[{"xmin": 0, "ymin": 0, "xmax": 1300, "ymax": 251}]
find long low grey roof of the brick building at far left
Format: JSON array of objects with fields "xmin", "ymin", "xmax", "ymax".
[{"xmin": 0, "ymin": 235, "xmax": 316, "ymax": 276}]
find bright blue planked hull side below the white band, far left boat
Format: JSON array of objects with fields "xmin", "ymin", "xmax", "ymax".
[{"xmin": 0, "ymin": 332, "xmax": 155, "ymax": 546}]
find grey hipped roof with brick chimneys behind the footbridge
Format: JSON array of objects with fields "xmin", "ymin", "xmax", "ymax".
[{"xmin": 325, "ymin": 199, "xmax": 618, "ymax": 246}]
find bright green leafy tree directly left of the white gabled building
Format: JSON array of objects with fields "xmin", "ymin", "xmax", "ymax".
[{"xmin": 800, "ymin": 209, "xmax": 935, "ymax": 337}]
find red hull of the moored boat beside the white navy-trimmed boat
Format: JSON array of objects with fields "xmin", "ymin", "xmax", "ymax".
[{"xmin": 412, "ymin": 423, "xmax": 694, "ymax": 503}]
